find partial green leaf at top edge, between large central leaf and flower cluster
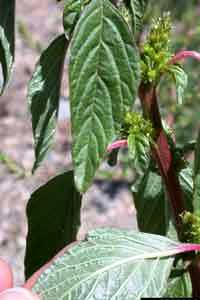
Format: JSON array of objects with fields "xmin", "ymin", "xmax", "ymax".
[{"xmin": 125, "ymin": 0, "xmax": 148, "ymax": 35}]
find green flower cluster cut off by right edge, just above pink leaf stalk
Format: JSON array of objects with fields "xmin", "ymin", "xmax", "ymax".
[{"xmin": 181, "ymin": 211, "xmax": 200, "ymax": 244}]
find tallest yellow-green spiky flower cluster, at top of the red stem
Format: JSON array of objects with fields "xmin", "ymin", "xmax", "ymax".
[{"xmin": 141, "ymin": 13, "xmax": 172, "ymax": 83}]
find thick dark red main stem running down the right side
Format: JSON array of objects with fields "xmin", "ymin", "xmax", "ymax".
[{"xmin": 139, "ymin": 83, "xmax": 200, "ymax": 297}]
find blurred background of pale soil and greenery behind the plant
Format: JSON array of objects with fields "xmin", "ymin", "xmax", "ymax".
[{"xmin": 0, "ymin": 0, "xmax": 200, "ymax": 284}]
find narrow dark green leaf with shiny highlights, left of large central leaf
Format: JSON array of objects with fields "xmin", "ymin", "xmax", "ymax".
[{"xmin": 28, "ymin": 34, "xmax": 68, "ymax": 171}]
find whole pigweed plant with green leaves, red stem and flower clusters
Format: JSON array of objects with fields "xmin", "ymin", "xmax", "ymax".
[{"xmin": 0, "ymin": 0, "xmax": 200, "ymax": 300}]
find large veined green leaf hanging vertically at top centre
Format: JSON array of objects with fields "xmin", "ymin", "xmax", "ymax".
[{"xmin": 69, "ymin": 0, "xmax": 139, "ymax": 191}]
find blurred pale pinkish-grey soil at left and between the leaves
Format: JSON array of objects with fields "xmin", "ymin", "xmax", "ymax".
[{"xmin": 0, "ymin": 0, "xmax": 136, "ymax": 284}]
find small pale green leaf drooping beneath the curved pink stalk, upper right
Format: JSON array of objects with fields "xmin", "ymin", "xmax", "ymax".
[{"xmin": 169, "ymin": 65, "xmax": 188, "ymax": 104}]
